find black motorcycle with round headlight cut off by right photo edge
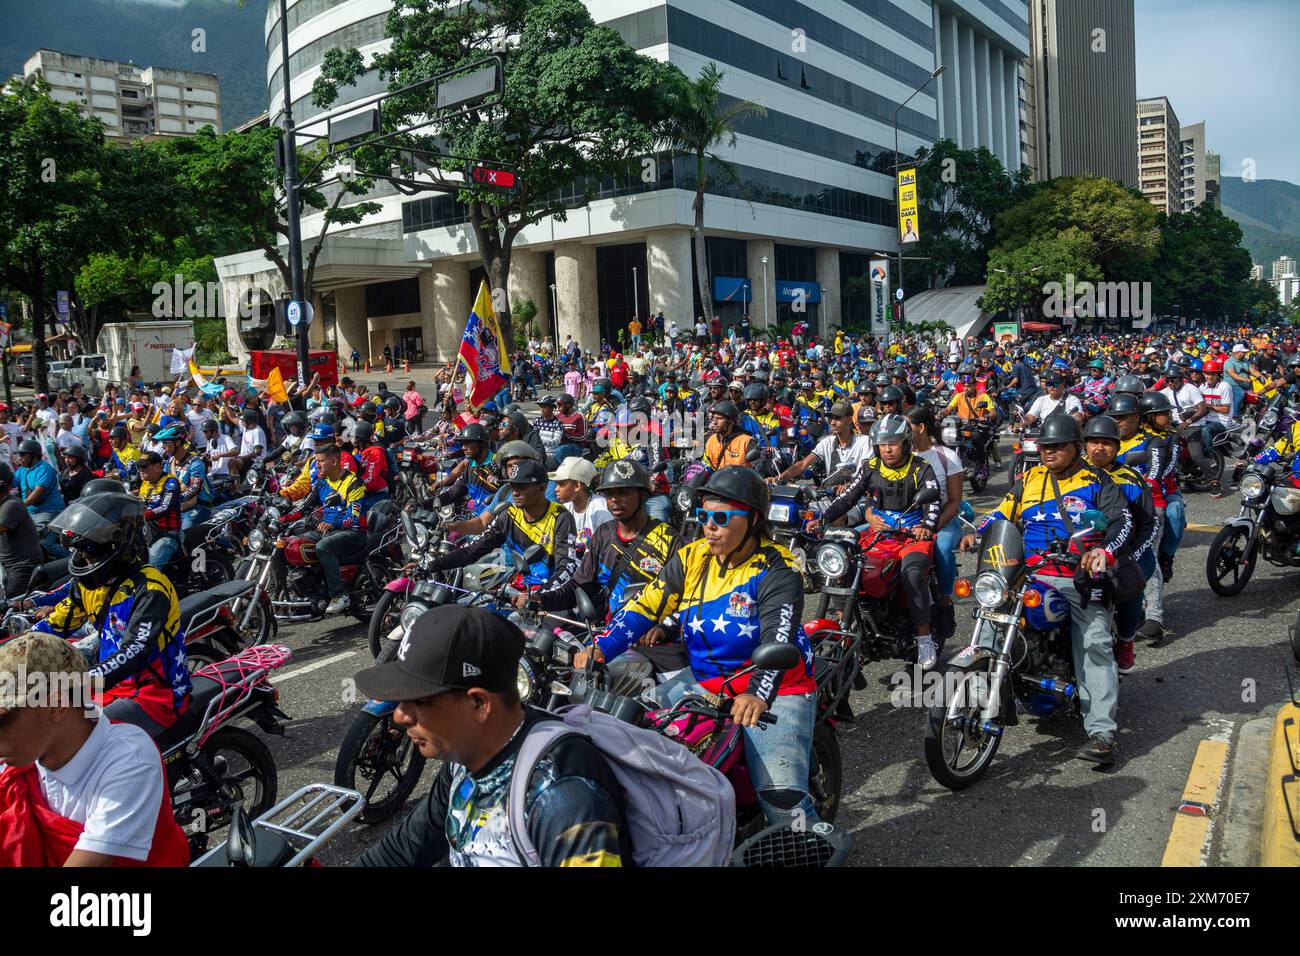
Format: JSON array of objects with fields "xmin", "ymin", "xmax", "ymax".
[{"xmin": 1205, "ymin": 462, "xmax": 1300, "ymax": 597}]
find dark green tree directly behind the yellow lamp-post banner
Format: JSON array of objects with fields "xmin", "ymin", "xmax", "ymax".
[{"xmin": 907, "ymin": 139, "xmax": 1030, "ymax": 289}]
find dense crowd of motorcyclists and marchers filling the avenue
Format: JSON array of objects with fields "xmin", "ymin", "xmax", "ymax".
[{"xmin": 0, "ymin": 324, "xmax": 1300, "ymax": 865}]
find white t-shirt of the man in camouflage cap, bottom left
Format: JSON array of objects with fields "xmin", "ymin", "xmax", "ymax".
[{"xmin": 36, "ymin": 709, "xmax": 164, "ymax": 860}]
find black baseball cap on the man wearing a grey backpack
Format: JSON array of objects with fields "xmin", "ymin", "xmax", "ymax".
[{"xmin": 356, "ymin": 605, "xmax": 524, "ymax": 704}]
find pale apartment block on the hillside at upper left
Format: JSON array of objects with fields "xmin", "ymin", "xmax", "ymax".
[{"xmin": 23, "ymin": 49, "xmax": 221, "ymax": 140}]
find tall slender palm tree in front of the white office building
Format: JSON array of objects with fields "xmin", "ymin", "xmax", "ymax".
[{"xmin": 666, "ymin": 62, "xmax": 767, "ymax": 330}]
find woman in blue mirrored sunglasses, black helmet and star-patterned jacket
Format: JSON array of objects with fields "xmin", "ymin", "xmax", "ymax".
[{"xmin": 573, "ymin": 466, "xmax": 818, "ymax": 823}]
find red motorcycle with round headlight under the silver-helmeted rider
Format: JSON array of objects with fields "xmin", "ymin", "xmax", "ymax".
[{"xmin": 805, "ymin": 489, "xmax": 943, "ymax": 671}]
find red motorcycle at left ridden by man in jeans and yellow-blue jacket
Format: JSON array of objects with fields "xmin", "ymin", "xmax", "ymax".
[{"xmin": 231, "ymin": 496, "xmax": 403, "ymax": 626}]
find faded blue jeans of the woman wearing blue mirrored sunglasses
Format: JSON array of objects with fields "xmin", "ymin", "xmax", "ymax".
[{"xmin": 653, "ymin": 669, "xmax": 820, "ymax": 825}]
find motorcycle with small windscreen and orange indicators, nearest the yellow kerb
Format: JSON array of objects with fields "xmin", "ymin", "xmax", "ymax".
[{"xmin": 924, "ymin": 509, "xmax": 1106, "ymax": 791}]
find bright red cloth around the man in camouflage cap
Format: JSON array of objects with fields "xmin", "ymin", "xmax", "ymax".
[{"xmin": 0, "ymin": 761, "xmax": 190, "ymax": 866}]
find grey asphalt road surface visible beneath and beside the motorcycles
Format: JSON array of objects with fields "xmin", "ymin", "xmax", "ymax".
[{"xmin": 253, "ymin": 447, "xmax": 1300, "ymax": 866}]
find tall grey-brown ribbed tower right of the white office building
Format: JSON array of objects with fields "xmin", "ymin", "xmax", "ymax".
[{"xmin": 1021, "ymin": 0, "xmax": 1138, "ymax": 186}]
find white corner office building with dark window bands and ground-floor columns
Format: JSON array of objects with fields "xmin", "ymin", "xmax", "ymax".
[{"xmin": 217, "ymin": 0, "xmax": 1028, "ymax": 359}]
